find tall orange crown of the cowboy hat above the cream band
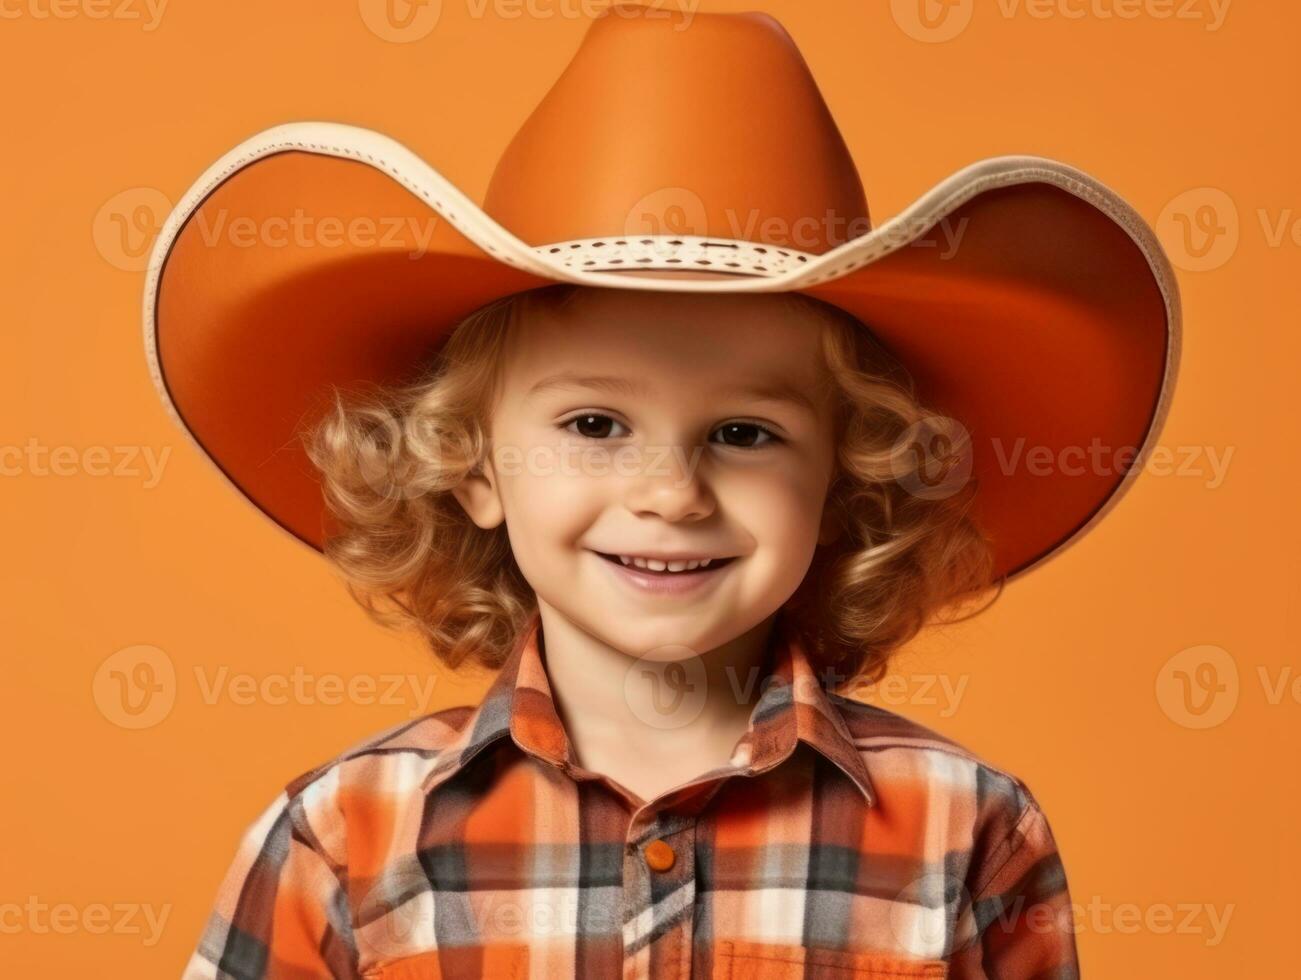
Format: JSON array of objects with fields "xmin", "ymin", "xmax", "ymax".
[{"xmin": 484, "ymin": 5, "xmax": 869, "ymax": 254}]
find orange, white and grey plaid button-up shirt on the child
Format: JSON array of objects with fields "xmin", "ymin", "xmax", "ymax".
[{"xmin": 185, "ymin": 614, "xmax": 1079, "ymax": 980}]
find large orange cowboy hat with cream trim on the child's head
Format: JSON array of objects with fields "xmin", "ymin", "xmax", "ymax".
[{"xmin": 144, "ymin": 5, "xmax": 1180, "ymax": 578}]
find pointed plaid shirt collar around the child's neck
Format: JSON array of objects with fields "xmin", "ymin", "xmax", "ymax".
[{"xmin": 424, "ymin": 610, "xmax": 876, "ymax": 806}]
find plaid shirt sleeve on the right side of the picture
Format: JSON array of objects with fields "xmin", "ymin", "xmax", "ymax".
[{"xmin": 948, "ymin": 786, "xmax": 1080, "ymax": 980}]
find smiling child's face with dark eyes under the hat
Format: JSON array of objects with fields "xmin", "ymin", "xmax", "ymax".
[{"xmin": 457, "ymin": 289, "xmax": 835, "ymax": 660}]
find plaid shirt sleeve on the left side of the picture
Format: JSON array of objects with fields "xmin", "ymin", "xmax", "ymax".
[{"xmin": 182, "ymin": 790, "xmax": 360, "ymax": 980}]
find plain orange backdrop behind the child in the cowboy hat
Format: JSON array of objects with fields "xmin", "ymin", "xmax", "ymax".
[{"xmin": 0, "ymin": 0, "xmax": 1301, "ymax": 977}]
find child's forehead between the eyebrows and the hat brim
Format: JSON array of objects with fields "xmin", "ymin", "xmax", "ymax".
[{"xmin": 502, "ymin": 289, "xmax": 824, "ymax": 387}]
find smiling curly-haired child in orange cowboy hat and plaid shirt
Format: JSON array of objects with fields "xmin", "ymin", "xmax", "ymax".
[{"xmin": 147, "ymin": 8, "xmax": 1177, "ymax": 980}]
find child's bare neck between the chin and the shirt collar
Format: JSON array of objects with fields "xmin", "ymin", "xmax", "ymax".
[{"xmin": 539, "ymin": 603, "xmax": 775, "ymax": 768}]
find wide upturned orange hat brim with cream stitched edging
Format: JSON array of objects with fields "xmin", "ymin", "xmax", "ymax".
[{"xmin": 144, "ymin": 122, "xmax": 1180, "ymax": 578}]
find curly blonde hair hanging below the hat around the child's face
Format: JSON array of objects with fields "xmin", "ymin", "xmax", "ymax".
[{"xmin": 304, "ymin": 284, "xmax": 1002, "ymax": 683}]
